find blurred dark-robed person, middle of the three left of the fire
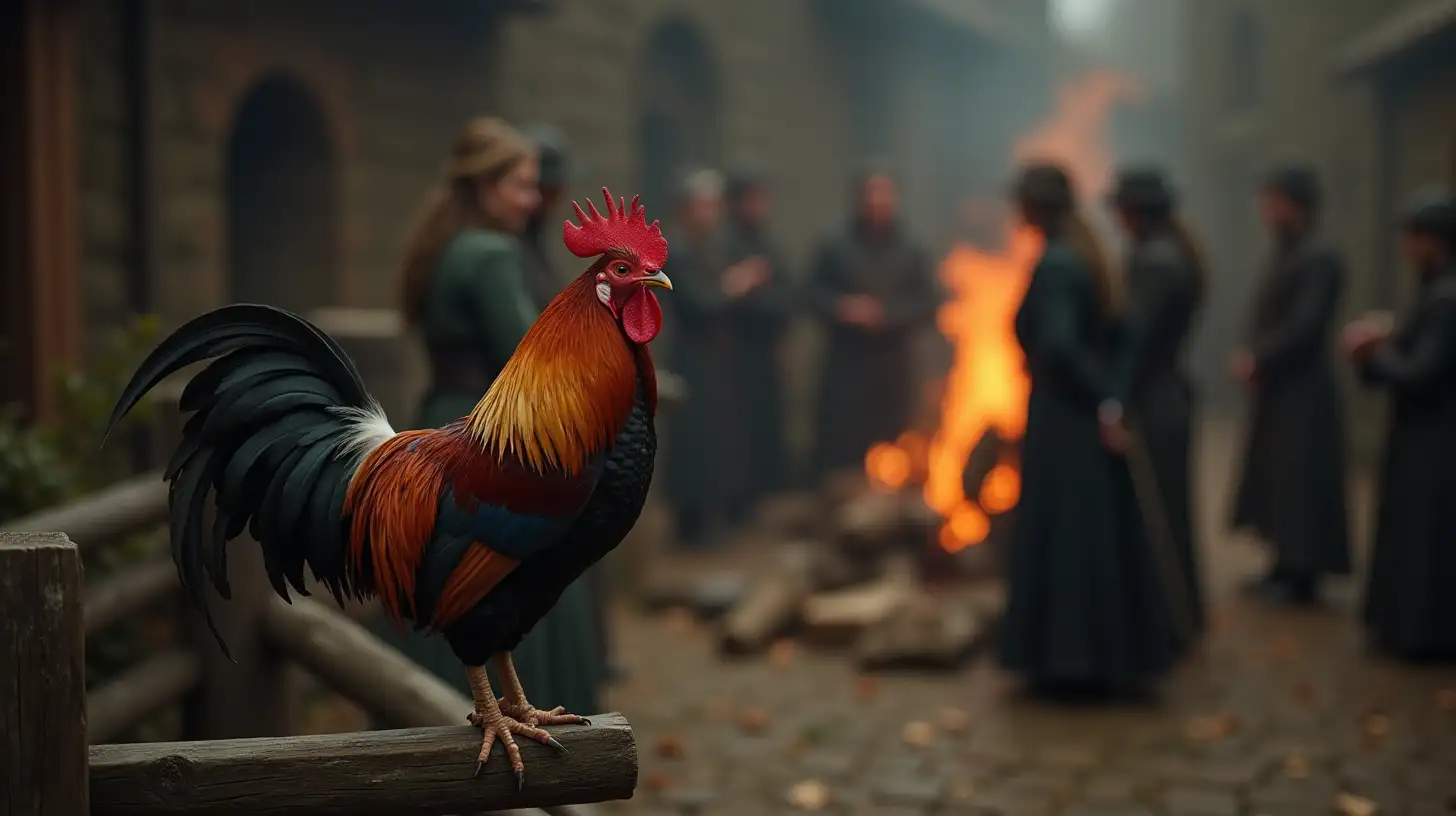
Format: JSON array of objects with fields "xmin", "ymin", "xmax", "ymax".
[{"xmin": 725, "ymin": 166, "xmax": 794, "ymax": 504}]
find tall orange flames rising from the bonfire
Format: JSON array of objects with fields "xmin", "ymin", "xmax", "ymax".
[{"xmin": 865, "ymin": 71, "xmax": 1142, "ymax": 552}]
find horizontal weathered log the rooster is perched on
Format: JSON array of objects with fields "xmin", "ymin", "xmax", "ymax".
[{"xmin": 90, "ymin": 714, "xmax": 638, "ymax": 816}]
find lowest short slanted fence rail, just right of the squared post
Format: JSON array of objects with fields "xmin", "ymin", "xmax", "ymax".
[{"xmin": 86, "ymin": 650, "xmax": 202, "ymax": 745}]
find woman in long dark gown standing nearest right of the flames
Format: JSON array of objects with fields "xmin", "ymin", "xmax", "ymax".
[{"xmin": 1000, "ymin": 165, "xmax": 1175, "ymax": 692}]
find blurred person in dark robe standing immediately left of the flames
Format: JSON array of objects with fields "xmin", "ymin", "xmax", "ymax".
[{"xmin": 803, "ymin": 169, "xmax": 939, "ymax": 479}]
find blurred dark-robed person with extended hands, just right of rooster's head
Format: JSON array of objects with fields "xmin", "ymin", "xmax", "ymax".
[{"xmin": 662, "ymin": 170, "xmax": 751, "ymax": 546}]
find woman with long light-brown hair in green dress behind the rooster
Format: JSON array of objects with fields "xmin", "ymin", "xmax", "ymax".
[{"xmin": 376, "ymin": 112, "xmax": 601, "ymax": 711}]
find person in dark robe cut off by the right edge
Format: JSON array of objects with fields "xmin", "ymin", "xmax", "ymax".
[{"xmin": 1342, "ymin": 191, "xmax": 1456, "ymax": 659}]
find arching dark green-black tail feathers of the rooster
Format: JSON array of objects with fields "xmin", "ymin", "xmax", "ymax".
[{"xmin": 106, "ymin": 305, "xmax": 374, "ymax": 657}]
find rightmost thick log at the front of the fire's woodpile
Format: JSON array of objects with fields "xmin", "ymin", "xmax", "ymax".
[{"xmin": 856, "ymin": 595, "xmax": 989, "ymax": 669}]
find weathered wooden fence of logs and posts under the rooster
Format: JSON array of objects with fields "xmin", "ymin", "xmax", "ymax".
[{"xmin": 0, "ymin": 474, "xmax": 638, "ymax": 816}]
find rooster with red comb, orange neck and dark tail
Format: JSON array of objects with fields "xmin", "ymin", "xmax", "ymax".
[{"xmin": 108, "ymin": 188, "xmax": 673, "ymax": 785}]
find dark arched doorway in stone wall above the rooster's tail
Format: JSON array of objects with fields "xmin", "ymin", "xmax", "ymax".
[{"xmin": 227, "ymin": 74, "xmax": 338, "ymax": 312}]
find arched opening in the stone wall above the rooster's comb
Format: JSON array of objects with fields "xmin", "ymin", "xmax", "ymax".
[{"xmin": 638, "ymin": 19, "xmax": 722, "ymax": 214}]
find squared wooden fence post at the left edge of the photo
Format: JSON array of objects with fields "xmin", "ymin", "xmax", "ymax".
[{"xmin": 0, "ymin": 533, "xmax": 90, "ymax": 816}]
